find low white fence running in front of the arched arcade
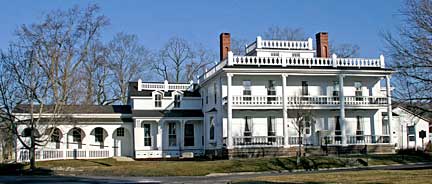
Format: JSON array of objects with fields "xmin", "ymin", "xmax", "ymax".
[{"xmin": 17, "ymin": 149, "xmax": 111, "ymax": 162}]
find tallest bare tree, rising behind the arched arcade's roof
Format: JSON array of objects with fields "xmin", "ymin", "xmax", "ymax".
[{"xmin": 16, "ymin": 5, "xmax": 108, "ymax": 104}]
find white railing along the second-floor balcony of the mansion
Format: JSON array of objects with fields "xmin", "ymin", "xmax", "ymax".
[{"xmin": 224, "ymin": 95, "xmax": 387, "ymax": 108}]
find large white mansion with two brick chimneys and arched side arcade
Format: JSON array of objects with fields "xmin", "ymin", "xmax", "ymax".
[{"xmin": 15, "ymin": 32, "xmax": 429, "ymax": 161}]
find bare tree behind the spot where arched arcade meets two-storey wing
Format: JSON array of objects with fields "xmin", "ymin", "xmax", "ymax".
[{"xmin": 107, "ymin": 33, "xmax": 151, "ymax": 104}]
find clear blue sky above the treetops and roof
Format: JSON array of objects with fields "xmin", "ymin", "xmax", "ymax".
[{"xmin": 0, "ymin": 0, "xmax": 404, "ymax": 58}]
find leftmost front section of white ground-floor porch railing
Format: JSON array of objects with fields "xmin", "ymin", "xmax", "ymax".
[{"xmin": 233, "ymin": 136, "xmax": 284, "ymax": 147}]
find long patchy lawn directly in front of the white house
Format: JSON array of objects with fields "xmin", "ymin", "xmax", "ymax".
[{"xmin": 22, "ymin": 155, "xmax": 432, "ymax": 176}]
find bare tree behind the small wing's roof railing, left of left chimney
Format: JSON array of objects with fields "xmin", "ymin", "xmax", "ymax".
[{"xmin": 153, "ymin": 37, "xmax": 215, "ymax": 83}]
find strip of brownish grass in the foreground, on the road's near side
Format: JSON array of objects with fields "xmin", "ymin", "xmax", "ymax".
[{"xmin": 233, "ymin": 169, "xmax": 432, "ymax": 184}]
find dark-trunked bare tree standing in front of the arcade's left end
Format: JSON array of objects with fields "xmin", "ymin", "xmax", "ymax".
[{"xmin": 0, "ymin": 48, "xmax": 62, "ymax": 169}]
